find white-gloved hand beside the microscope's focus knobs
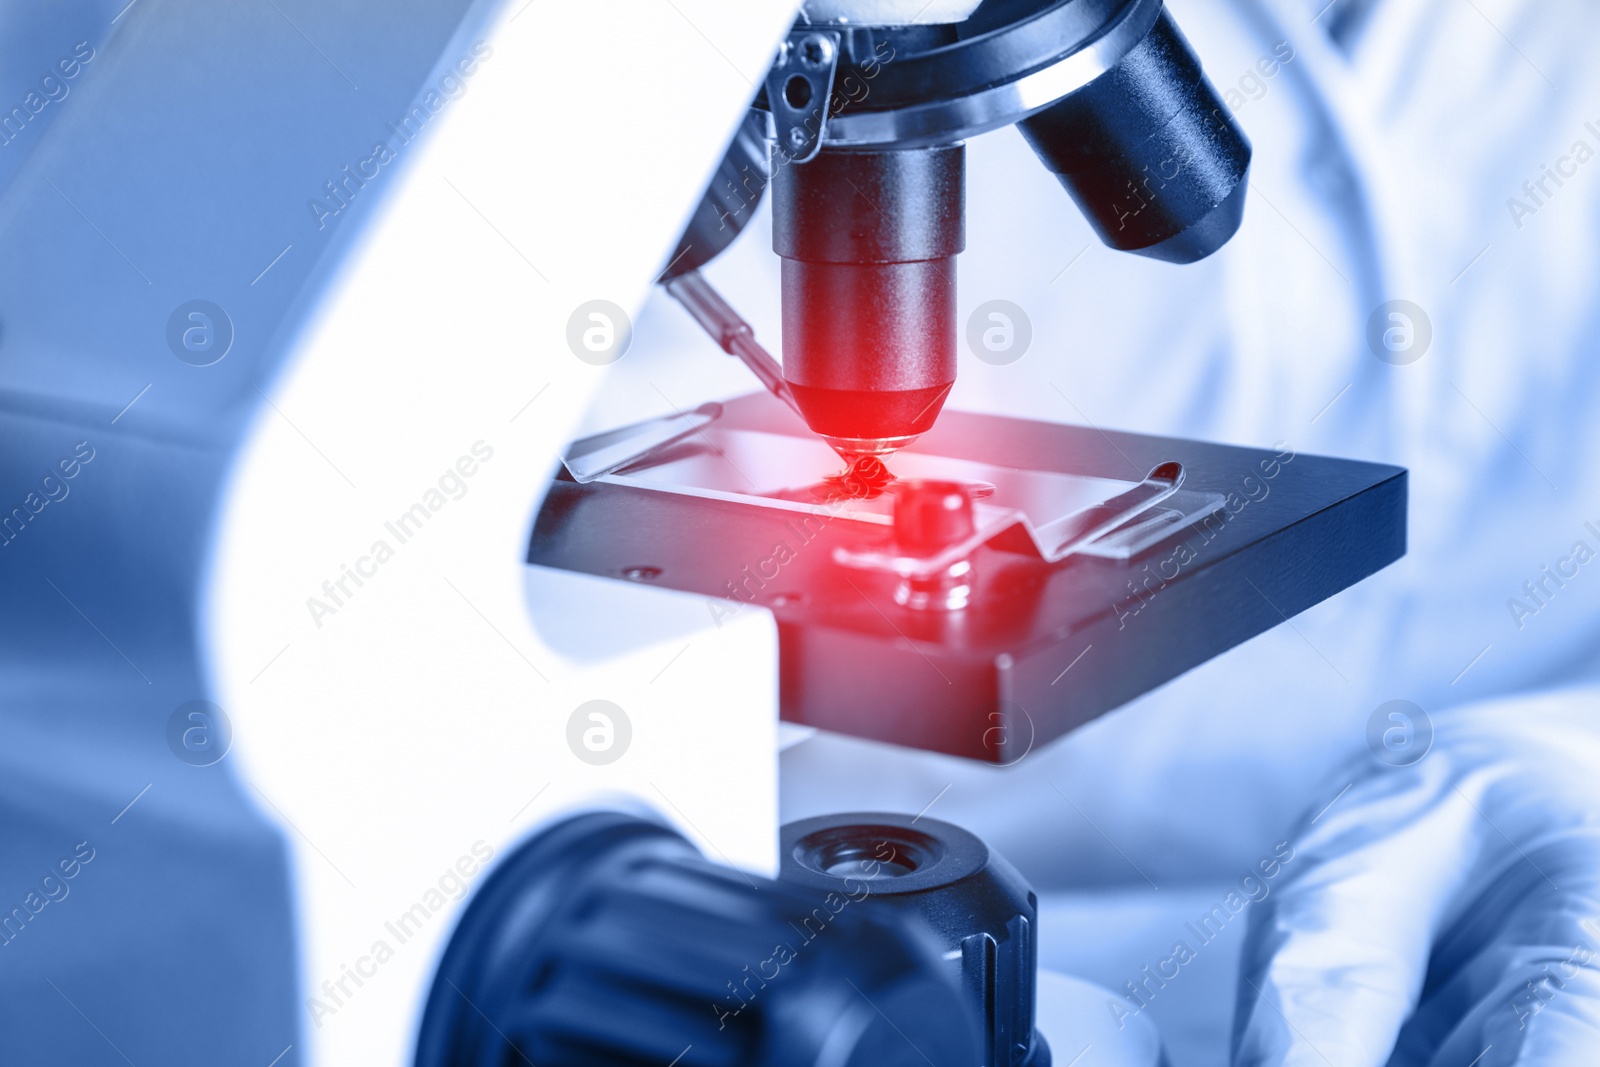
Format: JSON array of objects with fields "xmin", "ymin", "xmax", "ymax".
[{"xmin": 1234, "ymin": 689, "xmax": 1600, "ymax": 1067}]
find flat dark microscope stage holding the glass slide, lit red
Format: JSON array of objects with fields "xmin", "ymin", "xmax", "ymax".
[{"xmin": 528, "ymin": 394, "xmax": 1406, "ymax": 763}]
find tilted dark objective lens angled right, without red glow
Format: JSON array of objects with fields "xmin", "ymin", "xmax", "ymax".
[{"xmin": 1018, "ymin": 11, "xmax": 1250, "ymax": 262}]
